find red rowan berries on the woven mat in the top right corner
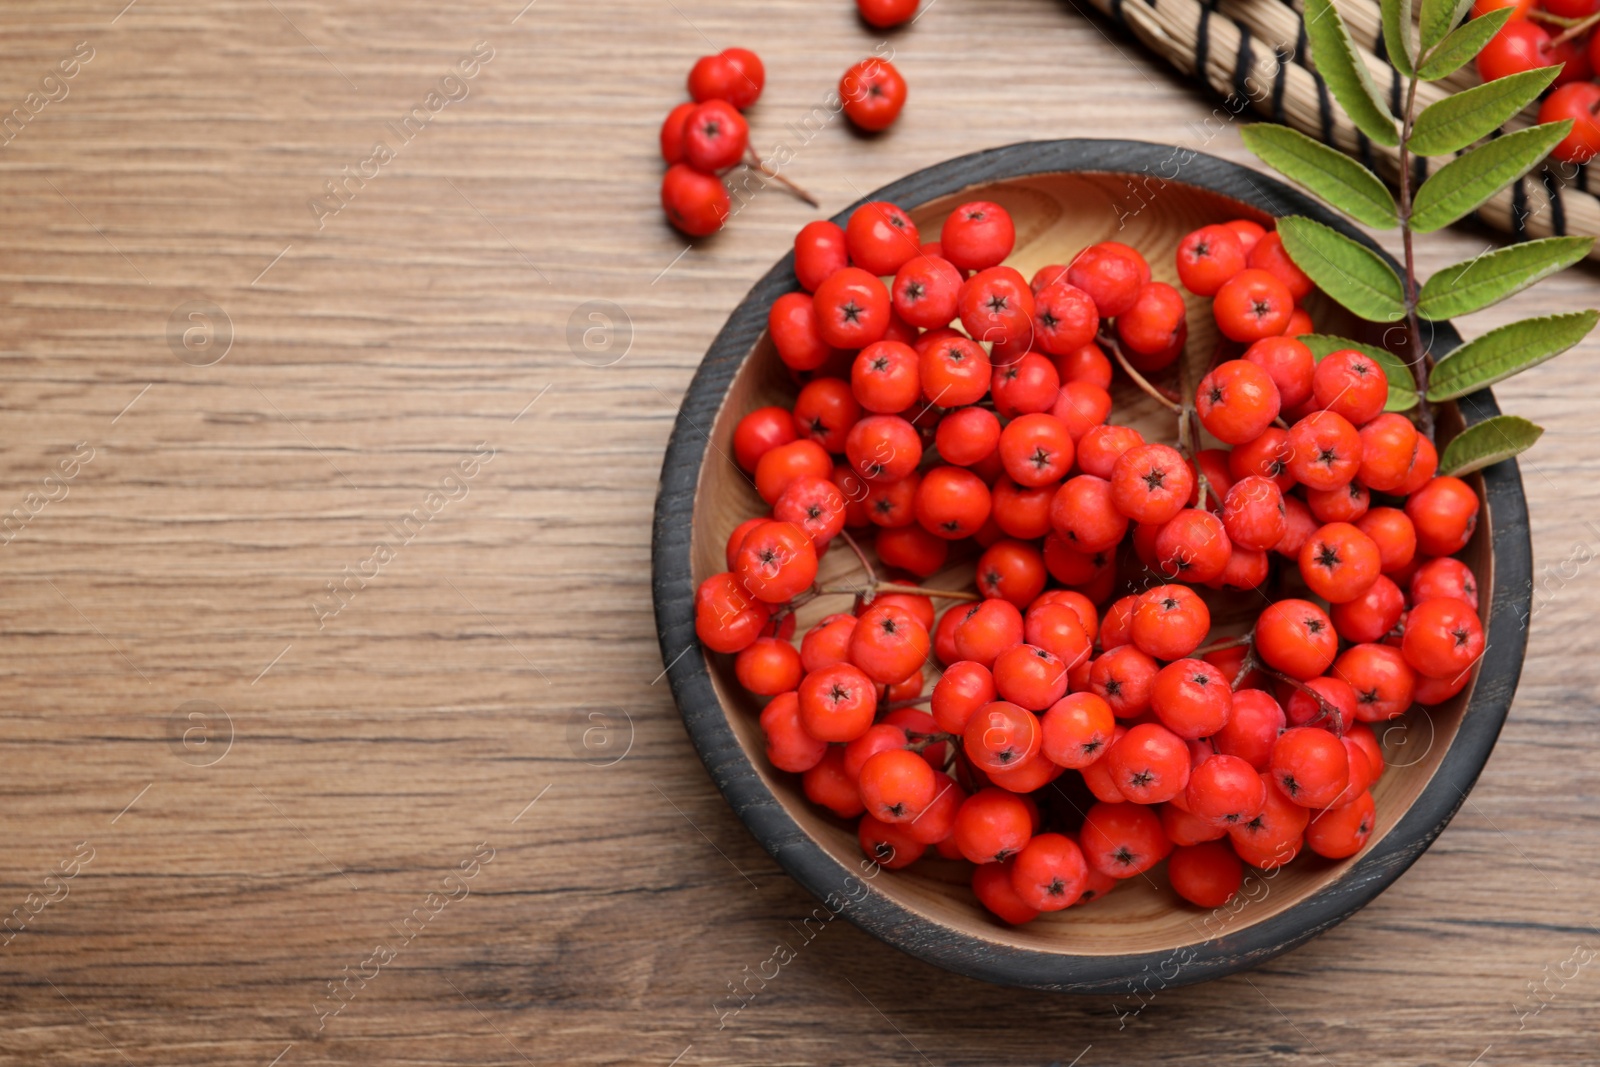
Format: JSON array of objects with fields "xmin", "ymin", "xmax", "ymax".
[{"xmin": 1472, "ymin": 0, "xmax": 1600, "ymax": 163}]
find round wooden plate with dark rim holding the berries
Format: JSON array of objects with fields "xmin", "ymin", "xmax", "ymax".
[{"xmin": 653, "ymin": 141, "xmax": 1531, "ymax": 995}]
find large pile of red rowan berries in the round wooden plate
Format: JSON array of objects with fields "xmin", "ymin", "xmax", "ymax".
[{"xmin": 696, "ymin": 194, "xmax": 1483, "ymax": 923}]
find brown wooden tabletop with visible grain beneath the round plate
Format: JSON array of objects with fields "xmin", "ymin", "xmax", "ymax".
[{"xmin": 0, "ymin": 0, "xmax": 1600, "ymax": 1067}]
